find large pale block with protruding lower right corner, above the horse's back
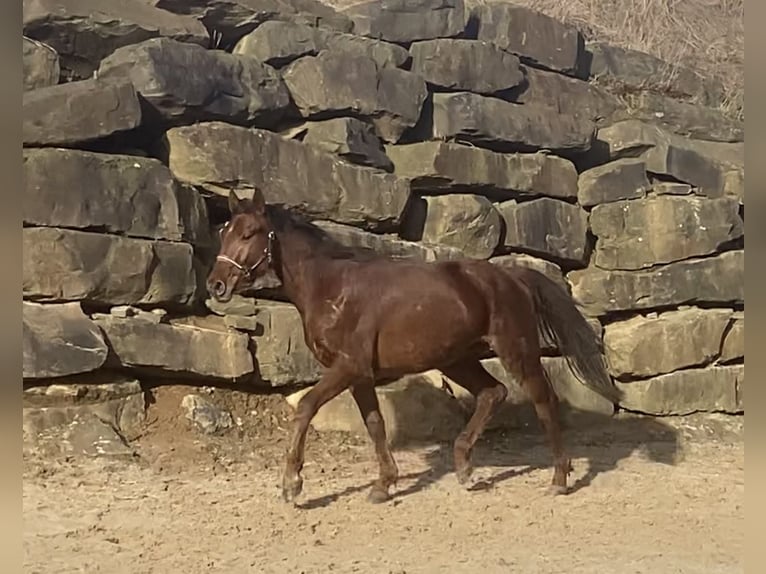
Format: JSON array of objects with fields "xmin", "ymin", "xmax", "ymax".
[{"xmin": 282, "ymin": 50, "xmax": 428, "ymax": 142}]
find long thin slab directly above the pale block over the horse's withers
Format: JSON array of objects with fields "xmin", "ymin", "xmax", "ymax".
[{"xmin": 233, "ymin": 20, "xmax": 410, "ymax": 68}]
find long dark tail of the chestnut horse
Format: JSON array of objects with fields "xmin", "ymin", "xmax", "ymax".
[{"xmin": 517, "ymin": 268, "xmax": 621, "ymax": 403}]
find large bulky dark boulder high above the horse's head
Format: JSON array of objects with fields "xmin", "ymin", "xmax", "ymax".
[{"xmin": 98, "ymin": 38, "xmax": 290, "ymax": 127}]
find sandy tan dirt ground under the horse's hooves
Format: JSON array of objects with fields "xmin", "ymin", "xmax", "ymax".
[{"xmin": 23, "ymin": 389, "xmax": 745, "ymax": 574}]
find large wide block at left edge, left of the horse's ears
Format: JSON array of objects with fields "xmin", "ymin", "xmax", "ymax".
[{"xmin": 22, "ymin": 148, "xmax": 209, "ymax": 244}]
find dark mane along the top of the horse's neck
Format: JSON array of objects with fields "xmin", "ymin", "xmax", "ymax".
[{"xmin": 266, "ymin": 204, "xmax": 381, "ymax": 261}]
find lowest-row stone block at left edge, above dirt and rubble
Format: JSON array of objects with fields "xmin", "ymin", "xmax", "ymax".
[{"xmin": 22, "ymin": 301, "xmax": 108, "ymax": 379}]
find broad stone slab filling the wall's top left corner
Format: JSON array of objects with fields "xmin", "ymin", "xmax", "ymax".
[{"xmin": 23, "ymin": 0, "xmax": 210, "ymax": 80}]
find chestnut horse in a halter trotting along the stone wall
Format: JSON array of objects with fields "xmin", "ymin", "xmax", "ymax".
[{"xmin": 207, "ymin": 190, "xmax": 618, "ymax": 502}]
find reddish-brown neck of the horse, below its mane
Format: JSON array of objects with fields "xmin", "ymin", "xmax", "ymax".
[{"xmin": 275, "ymin": 229, "xmax": 323, "ymax": 314}]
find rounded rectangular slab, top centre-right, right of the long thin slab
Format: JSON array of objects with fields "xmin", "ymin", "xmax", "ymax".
[{"xmin": 410, "ymin": 38, "xmax": 524, "ymax": 95}]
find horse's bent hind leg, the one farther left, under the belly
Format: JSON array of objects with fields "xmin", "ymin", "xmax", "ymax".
[{"xmin": 442, "ymin": 361, "xmax": 508, "ymax": 488}]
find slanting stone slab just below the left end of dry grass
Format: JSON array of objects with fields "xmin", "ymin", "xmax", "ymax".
[{"xmin": 502, "ymin": 66, "xmax": 627, "ymax": 126}]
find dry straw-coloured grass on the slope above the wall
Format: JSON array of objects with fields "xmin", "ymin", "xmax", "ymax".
[{"xmin": 322, "ymin": 0, "xmax": 745, "ymax": 119}]
